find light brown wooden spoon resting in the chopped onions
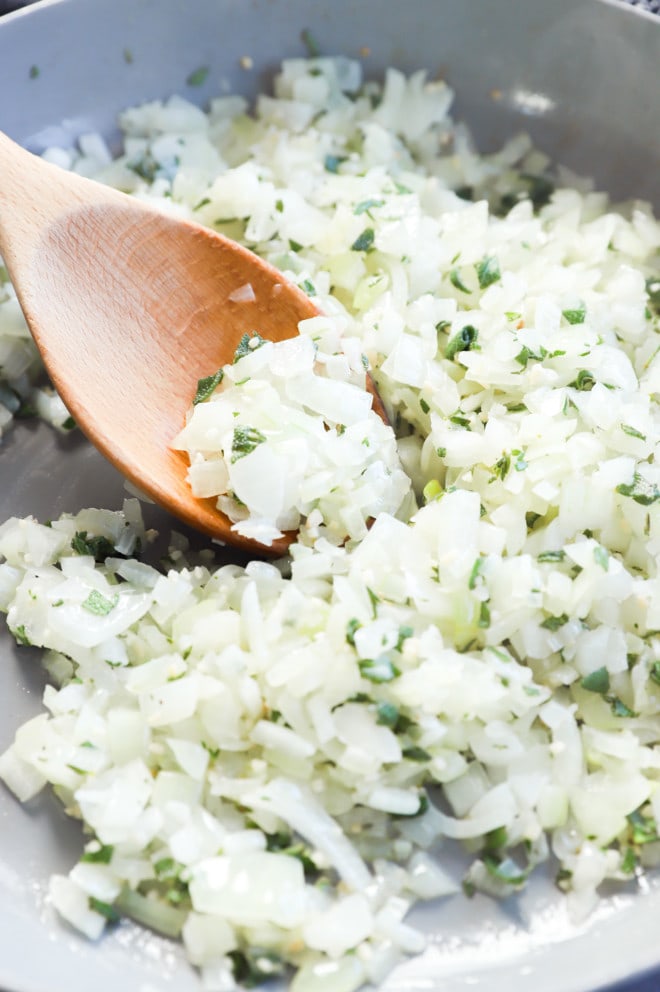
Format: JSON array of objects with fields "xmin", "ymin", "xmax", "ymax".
[{"xmin": 0, "ymin": 133, "xmax": 385, "ymax": 553}]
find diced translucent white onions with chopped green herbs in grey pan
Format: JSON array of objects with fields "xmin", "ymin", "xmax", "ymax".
[{"xmin": 0, "ymin": 59, "xmax": 660, "ymax": 992}]
